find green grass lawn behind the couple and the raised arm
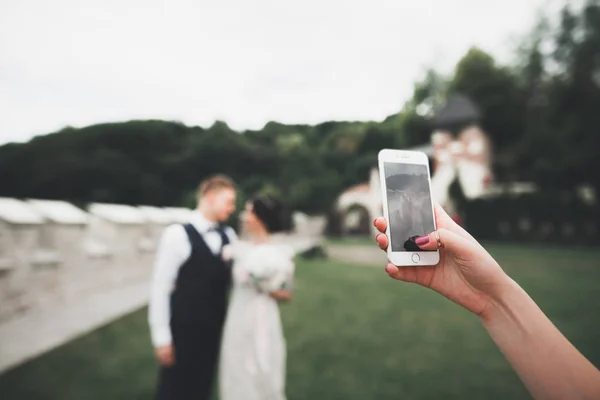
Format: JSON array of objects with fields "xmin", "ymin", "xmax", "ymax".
[{"xmin": 0, "ymin": 246, "xmax": 600, "ymax": 400}]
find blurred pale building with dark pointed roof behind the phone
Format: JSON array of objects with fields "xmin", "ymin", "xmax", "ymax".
[{"xmin": 336, "ymin": 95, "xmax": 493, "ymax": 235}]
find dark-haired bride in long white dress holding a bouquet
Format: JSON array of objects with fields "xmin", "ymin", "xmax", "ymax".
[{"xmin": 219, "ymin": 196, "xmax": 294, "ymax": 400}]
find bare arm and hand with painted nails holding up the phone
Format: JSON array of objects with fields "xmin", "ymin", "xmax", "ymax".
[{"xmin": 374, "ymin": 206, "xmax": 600, "ymax": 400}]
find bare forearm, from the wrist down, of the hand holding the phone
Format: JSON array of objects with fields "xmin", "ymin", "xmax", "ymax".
[{"xmin": 481, "ymin": 282, "xmax": 600, "ymax": 399}]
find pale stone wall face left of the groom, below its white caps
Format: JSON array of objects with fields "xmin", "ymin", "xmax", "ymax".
[{"xmin": 0, "ymin": 202, "xmax": 175, "ymax": 324}]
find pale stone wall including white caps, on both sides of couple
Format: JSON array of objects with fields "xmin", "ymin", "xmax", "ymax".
[{"xmin": 0, "ymin": 198, "xmax": 324, "ymax": 324}]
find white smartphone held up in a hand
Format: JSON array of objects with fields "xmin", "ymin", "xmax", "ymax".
[{"xmin": 378, "ymin": 149, "xmax": 440, "ymax": 266}]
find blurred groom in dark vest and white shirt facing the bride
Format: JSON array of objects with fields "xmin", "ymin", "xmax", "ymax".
[{"xmin": 148, "ymin": 175, "xmax": 237, "ymax": 400}]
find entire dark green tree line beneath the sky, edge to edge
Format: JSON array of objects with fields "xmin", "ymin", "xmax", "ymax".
[{"xmin": 0, "ymin": 0, "xmax": 600, "ymax": 213}]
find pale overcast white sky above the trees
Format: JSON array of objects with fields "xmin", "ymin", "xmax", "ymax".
[{"xmin": 0, "ymin": 0, "xmax": 555, "ymax": 144}]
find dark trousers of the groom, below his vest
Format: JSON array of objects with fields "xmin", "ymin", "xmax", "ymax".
[{"xmin": 158, "ymin": 321, "xmax": 222, "ymax": 400}]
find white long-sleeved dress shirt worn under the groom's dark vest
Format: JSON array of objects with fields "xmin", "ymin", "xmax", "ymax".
[{"xmin": 148, "ymin": 211, "xmax": 237, "ymax": 347}]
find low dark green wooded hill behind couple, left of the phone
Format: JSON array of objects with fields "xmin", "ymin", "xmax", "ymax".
[{"xmin": 0, "ymin": 117, "xmax": 397, "ymax": 212}]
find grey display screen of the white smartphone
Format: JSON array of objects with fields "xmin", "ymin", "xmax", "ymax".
[{"xmin": 383, "ymin": 162, "xmax": 434, "ymax": 252}]
